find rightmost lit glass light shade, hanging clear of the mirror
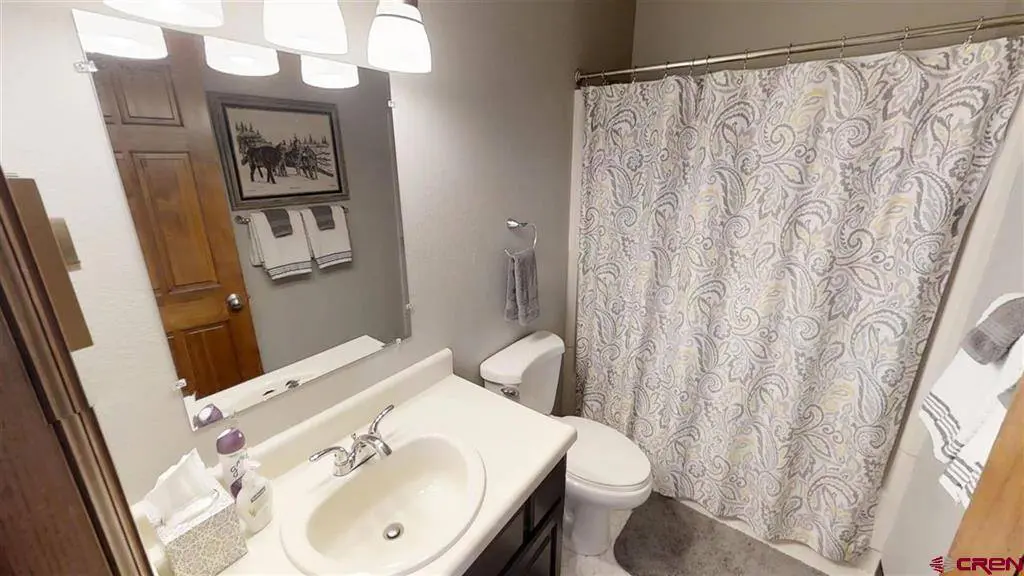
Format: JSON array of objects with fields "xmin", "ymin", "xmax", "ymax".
[{"xmin": 367, "ymin": 0, "xmax": 430, "ymax": 74}]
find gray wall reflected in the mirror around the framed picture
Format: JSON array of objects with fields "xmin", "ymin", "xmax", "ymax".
[{"xmin": 203, "ymin": 52, "xmax": 404, "ymax": 371}]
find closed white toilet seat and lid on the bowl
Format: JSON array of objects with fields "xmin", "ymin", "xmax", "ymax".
[{"xmin": 561, "ymin": 416, "xmax": 650, "ymax": 493}]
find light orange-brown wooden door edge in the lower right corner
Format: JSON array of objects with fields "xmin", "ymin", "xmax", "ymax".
[{"xmin": 949, "ymin": 378, "xmax": 1024, "ymax": 575}]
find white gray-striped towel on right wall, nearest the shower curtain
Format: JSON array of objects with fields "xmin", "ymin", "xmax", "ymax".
[{"xmin": 918, "ymin": 294, "xmax": 1024, "ymax": 462}]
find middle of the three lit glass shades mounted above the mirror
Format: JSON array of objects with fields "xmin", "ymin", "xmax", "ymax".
[{"xmin": 263, "ymin": 0, "xmax": 348, "ymax": 54}]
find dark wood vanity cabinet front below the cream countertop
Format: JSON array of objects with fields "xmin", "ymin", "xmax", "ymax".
[{"xmin": 465, "ymin": 458, "xmax": 565, "ymax": 576}]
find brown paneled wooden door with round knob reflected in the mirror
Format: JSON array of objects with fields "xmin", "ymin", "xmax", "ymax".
[{"xmin": 90, "ymin": 31, "xmax": 263, "ymax": 397}]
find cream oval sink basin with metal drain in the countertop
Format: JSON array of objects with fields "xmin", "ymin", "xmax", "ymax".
[{"xmin": 281, "ymin": 436, "xmax": 484, "ymax": 576}]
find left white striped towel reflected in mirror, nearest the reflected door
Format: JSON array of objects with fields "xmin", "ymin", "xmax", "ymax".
[{"xmin": 249, "ymin": 210, "xmax": 312, "ymax": 280}]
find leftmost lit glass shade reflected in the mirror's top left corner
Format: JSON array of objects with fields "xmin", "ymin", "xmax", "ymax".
[{"xmin": 72, "ymin": 10, "xmax": 167, "ymax": 60}]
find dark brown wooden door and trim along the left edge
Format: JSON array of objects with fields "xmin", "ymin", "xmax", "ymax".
[{"xmin": 0, "ymin": 168, "xmax": 151, "ymax": 575}]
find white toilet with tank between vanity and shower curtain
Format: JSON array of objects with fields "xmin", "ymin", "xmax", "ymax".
[{"xmin": 480, "ymin": 332, "xmax": 651, "ymax": 556}]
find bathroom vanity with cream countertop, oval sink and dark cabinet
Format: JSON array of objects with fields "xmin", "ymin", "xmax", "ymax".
[{"xmin": 136, "ymin": 351, "xmax": 577, "ymax": 576}]
